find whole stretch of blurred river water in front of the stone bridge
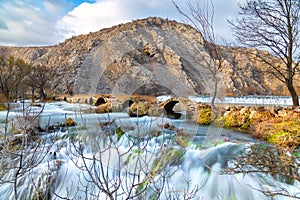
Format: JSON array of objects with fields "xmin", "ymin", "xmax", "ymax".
[{"xmin": 0, "ymin": 99, "xmax": 300, "ymax": 200}]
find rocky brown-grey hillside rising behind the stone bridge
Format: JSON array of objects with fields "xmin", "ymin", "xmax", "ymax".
[{"xmin": 0, "ymin": 17, "xmax": 299, "ymax": 96}]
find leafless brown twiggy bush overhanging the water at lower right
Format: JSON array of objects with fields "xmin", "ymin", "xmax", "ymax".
[{"xmin": 222, "ymin": 144, "xmax": 300, "ymax": 199}]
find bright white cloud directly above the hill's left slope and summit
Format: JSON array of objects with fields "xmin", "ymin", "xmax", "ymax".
[{"xmin": 57, "ymin": 0, "xmax": 174, "ymax": 37}]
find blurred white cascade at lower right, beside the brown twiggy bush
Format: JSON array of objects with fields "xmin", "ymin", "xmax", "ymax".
[{"xmin": 159, "ymin": 142, "xmax": 300, "ymax": 200}]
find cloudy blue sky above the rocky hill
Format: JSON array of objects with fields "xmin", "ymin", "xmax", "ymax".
[{"xmin": 0, "ymin": 0, "xmax": 245, "ymax": 46}]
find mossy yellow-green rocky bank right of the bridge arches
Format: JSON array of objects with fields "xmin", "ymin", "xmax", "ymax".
[{"xmin": 198, "ymin": 106, "xmax": 300, "ymax": 149}]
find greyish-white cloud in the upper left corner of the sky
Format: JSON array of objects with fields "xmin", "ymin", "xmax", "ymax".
[{"xmin": 0, "ymin": 0, "xmax": 70, "ymax": 46}]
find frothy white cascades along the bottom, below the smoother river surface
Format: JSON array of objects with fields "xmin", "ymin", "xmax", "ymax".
[{"xmin": 0, "ymin": 130, "xmax": 300, "ymax": 200}]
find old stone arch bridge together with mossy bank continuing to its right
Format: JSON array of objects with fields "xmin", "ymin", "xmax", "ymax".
[{"xmin": 48, "ymin": 94, "xmax": 300, "ymax": 149}]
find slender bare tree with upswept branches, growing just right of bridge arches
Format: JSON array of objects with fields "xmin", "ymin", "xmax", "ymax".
[{"xmin": 172, "ymin": 0, "xmax": 225, "ymax": 108}]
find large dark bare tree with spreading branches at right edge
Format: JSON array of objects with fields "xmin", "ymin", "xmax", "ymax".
[{"xmin": 229, "ymin": 0, "xmax": 300, "ymax": 106}]
